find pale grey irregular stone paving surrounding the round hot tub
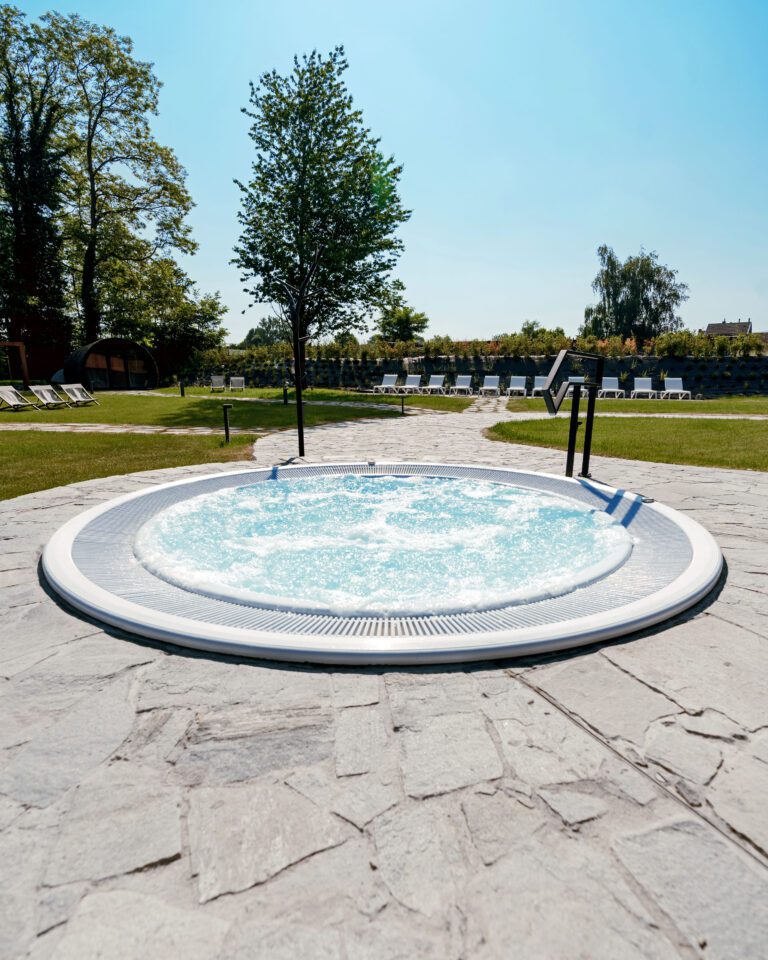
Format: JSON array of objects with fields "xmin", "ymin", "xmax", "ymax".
[{"xmin": 0, "ymin": 400, "xmax": 768, "ymax": 960}]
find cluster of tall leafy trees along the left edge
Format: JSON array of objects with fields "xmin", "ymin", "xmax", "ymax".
[{"xmin": 0, "ymin": 5, "xmax": 226, "ymax": 375}]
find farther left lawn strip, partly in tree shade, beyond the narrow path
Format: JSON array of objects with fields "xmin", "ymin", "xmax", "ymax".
[{"xmin": 6, "ymin": 393, "xmax": 395, "ymax": 430}]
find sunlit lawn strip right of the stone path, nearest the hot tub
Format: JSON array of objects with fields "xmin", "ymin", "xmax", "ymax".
[{"xmin": 488, "ymin": 417, "xmax": 768, "ymax": 470}]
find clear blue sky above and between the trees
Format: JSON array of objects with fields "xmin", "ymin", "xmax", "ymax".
[{"xmin": 20, "ymin": 0, "xmax": 768, "ymax": 339}]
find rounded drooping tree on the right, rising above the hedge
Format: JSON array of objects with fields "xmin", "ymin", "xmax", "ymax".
[{"xmin": 580, "ymin": 244, "xmax": 688, "ymax": 346}]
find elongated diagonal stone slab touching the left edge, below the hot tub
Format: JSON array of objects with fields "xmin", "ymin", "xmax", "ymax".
[{"xmin": 0, "ymin": 678, "xmax": 134, "ymax": 807}]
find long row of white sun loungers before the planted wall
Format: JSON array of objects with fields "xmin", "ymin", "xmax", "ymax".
[{"xmin": 373, "ymin": 373, "xmax": 691, "ymax": 400}]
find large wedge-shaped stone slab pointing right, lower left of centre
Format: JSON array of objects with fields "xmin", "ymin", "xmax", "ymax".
[{"xmin": 189, "ymin": 781, "xmax": 349, "ymax": 903}]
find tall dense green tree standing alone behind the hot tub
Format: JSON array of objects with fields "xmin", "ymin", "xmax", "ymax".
[{"xmin": 234, "ymin": 47, "xmax": 410, "ymax": 370}]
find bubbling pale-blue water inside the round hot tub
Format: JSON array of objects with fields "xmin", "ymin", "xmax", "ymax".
[{"xmin": 134, "ymin": 475, "xmax": 632, "ymax": 616}]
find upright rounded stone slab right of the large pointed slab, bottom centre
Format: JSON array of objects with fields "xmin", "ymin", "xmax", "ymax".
[{"xmin": 373, "ymin": 803, "xmax": 467, "ymax": 918}]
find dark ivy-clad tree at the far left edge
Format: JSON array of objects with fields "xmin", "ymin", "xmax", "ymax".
[{"xmin": 0, "ymin": 6, "xmax": 72, "ymax": 358}]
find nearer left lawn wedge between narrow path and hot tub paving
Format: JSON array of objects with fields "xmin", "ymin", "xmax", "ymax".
[{"xmin": 0, "ymin": 430, "xmax": 254, "ymax": 500}]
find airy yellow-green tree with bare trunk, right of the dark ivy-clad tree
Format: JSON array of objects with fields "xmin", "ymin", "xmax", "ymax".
[{"xmin": 42, "ymin": 13, "xmax": 195, "ymax": 341}]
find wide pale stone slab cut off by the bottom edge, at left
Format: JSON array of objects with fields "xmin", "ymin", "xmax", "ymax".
[{"xmin": 52, "ymin": 890, "xmax": 229, "ymax": 960}]
